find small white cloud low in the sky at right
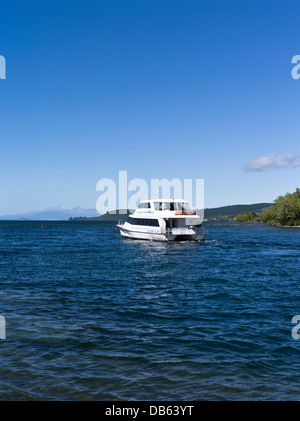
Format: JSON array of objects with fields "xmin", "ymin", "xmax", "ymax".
[{"xmin": 245, "ymin": 154, "xmax": 300, "ymax": 171}]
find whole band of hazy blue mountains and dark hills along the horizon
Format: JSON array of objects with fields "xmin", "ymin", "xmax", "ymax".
[{"xmin": 0, "ymin": 203, "xmax": 273, "ymax": 221}]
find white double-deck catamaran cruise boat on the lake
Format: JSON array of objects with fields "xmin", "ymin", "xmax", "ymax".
[{"xmin": 117, "ymin": 199, "xmax": 207, "ymax": 241}]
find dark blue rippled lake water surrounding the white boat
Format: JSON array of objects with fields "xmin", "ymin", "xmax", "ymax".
[{"xmin": 0, "ymin": 221, "xmax": 300, "ymax": 400}]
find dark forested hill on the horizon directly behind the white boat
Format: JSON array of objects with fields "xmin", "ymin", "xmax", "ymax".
[{"xmin": 70, "ymin": 203, "xmax": 273, "ymax": 221}]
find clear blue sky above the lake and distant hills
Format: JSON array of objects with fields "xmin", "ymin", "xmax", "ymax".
[{"xmin": 0, "ymin": 0, "xmax": 300, "ymax": 215}]
